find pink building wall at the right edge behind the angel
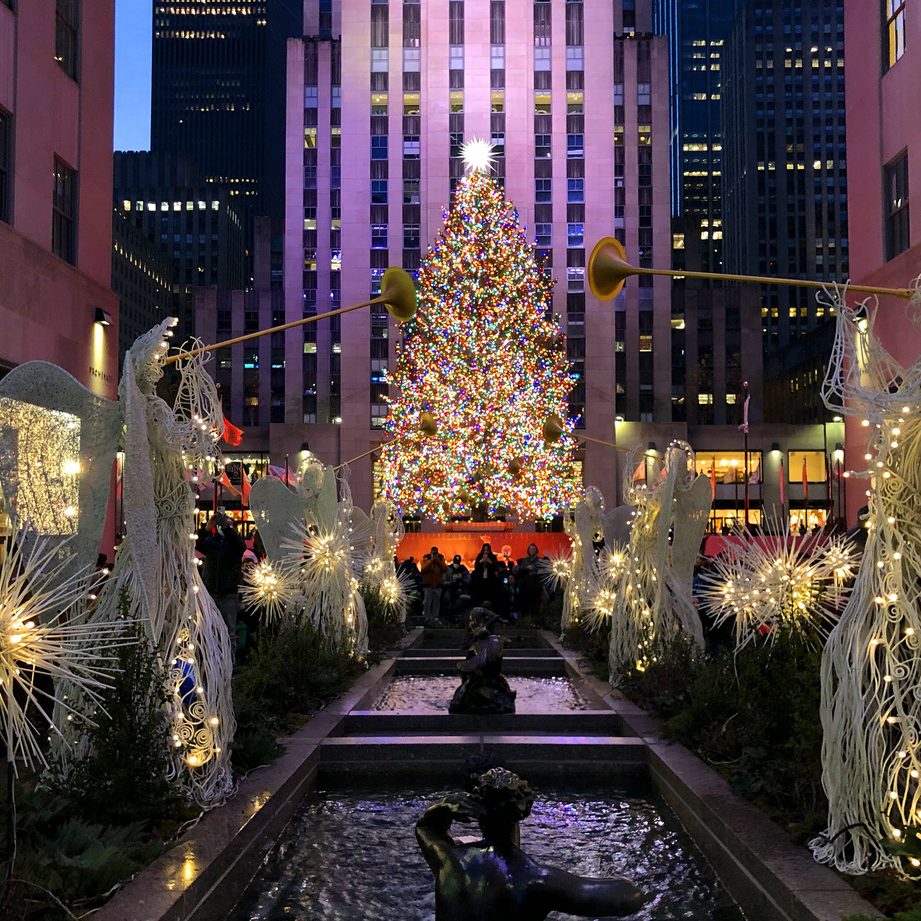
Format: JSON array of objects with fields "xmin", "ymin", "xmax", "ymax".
[{"xmin": 844, "ymin": 0, "xmax": 921, "ymax": 510}]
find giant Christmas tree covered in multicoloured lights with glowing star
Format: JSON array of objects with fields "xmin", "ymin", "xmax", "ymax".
[{"xmin": 382, "ymin": 141, "xmax": 574, "ymax": 520}]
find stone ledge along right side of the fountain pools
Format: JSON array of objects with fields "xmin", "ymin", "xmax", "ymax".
[{"xmin": 548, "ymin": 634, "xmax": 883, "ymax": 921}]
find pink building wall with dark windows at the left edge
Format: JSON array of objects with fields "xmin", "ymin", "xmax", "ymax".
[{"xmin": 0, "ymin": 0, "xmax": 118, "ymax": 396}]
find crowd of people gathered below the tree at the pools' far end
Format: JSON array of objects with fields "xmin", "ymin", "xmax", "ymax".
[{"xmin": 397, "ymin": 543, "xmax": 544, "ymax": 624}]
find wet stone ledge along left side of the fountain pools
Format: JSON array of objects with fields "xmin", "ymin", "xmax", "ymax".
[{"xmin": 93, "ymin": 630, "xmax": 421, "ymax": 921}]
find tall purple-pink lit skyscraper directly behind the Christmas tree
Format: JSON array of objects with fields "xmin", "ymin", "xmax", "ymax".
[{"xmin": 280, "ymin": 0, "xmax": 672, "ymax": 507}]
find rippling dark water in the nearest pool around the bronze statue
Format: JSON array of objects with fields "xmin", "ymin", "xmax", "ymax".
[{"xmin": 230, "ymin": 790, "xmax": 742, "ymax": 921}]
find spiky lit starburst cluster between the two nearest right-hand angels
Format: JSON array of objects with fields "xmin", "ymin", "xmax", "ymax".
[{"xmin": 699, "ymin": 522, "xmax": 857, "ymax": 649}]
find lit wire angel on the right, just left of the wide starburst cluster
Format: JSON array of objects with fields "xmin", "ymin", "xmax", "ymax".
[{"xmin": 608, "ymin": 441, "xmax": 710, "ymax": 686}]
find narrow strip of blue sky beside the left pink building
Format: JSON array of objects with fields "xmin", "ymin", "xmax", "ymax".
[{"xmin": 115, "ymin": 0, "xmax": 153, "ymax": 150}]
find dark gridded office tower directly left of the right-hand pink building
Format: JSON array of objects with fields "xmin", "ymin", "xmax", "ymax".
[{"xmin": 722, "ymin": 0, "xmax": 859, "ymax": 423}]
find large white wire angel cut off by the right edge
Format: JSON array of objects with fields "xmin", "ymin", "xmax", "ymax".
[{"xmin": 810, "ymin": 288, "xmax": 921, "ymax": 878}]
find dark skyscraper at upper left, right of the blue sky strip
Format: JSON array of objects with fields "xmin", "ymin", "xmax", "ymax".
[{"xmin": 150, "ymin": 0, "xmax": 302, "ymax": 230}]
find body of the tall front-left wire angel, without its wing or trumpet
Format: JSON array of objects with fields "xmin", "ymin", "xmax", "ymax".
[{"xmin": 63, "ymin": 319, "xmax": 235, "ymax": 807}]
